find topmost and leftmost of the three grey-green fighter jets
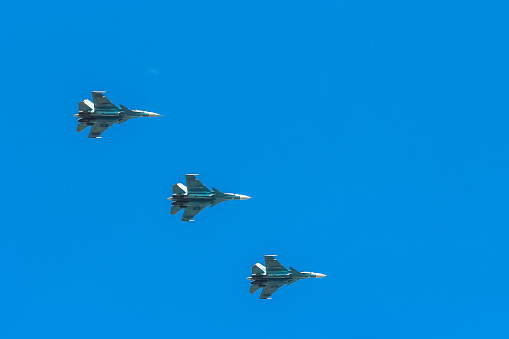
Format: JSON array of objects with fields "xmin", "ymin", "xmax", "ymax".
[{"xmin": 74, "ymin": 91, "xmax": 160, "ymax": 139}]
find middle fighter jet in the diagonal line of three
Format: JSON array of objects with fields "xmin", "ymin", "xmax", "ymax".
[{"xmin": 168, "ymin": 174, "xmax": 251, "ymax": 221}]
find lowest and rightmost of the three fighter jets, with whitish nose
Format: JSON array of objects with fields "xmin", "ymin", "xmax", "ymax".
[{"xmin": 247, "ymin": 255, "xmax": 326, "ymax": 299}]
